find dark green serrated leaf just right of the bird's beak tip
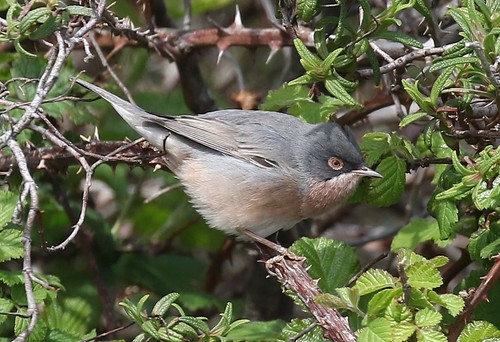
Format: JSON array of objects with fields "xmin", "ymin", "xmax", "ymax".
[{"xmin": 368, "ymin": 156, "xmax": 406, "ymax": 206}]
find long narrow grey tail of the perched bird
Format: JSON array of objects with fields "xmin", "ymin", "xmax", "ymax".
[{"xmin": 75, "ymin": 79, "xmax": 170, "ymax": 150}]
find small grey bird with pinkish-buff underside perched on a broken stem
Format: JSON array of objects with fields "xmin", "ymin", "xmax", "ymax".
[{"xmin": 76, "ymin": 79, "xmax": 382, "ymax": 241}]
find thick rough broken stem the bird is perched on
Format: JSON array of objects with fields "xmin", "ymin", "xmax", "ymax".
[{"xmin": 265, "ymin": 255, "xmax": 356, "ymax": 342}]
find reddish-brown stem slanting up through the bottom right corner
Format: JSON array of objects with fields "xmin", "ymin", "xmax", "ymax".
[{"xmin": 448, "ymin": 255, "xmax": 500, "ymax": 342}]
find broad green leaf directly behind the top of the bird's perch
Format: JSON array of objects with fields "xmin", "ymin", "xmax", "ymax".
[{"xmin": 290, "ymin": 238, "xmax": 359, "ymax": 293}]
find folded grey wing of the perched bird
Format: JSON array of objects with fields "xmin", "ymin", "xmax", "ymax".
[{"xmin": 162, "ymin": 110, "xmax": 304, "ymax": 167}]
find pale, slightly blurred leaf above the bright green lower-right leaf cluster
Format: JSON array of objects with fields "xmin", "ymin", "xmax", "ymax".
[{"xmin": 391, "ymin": 219, "xmax": 441, "ymax": 251}]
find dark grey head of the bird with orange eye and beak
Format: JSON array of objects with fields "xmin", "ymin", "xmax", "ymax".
[{"xmin": 298, "ymin": 123, "xmax": 379, "ymax": 181}]
